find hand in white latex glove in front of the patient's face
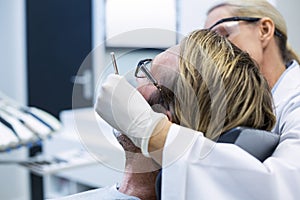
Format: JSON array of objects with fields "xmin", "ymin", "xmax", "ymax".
[{"xmin": 95, "ymin": 74, "xmax": 167, "ymax": 156}]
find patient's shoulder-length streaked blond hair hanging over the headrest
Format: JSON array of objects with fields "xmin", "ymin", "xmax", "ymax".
[{"xmin": 174, "ymin": 30, "xmax": 275, "ymax": 139}]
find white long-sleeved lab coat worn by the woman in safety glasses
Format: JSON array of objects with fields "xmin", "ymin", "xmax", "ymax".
[{"xmin": 162, "ymin": 61, "xmax": 300, "ymax": 200}]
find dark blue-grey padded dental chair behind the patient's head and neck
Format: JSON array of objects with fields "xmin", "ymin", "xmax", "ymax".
[{"xmin": 155, "ymin": 126, "xmax": 280, "ymax": 200}]
